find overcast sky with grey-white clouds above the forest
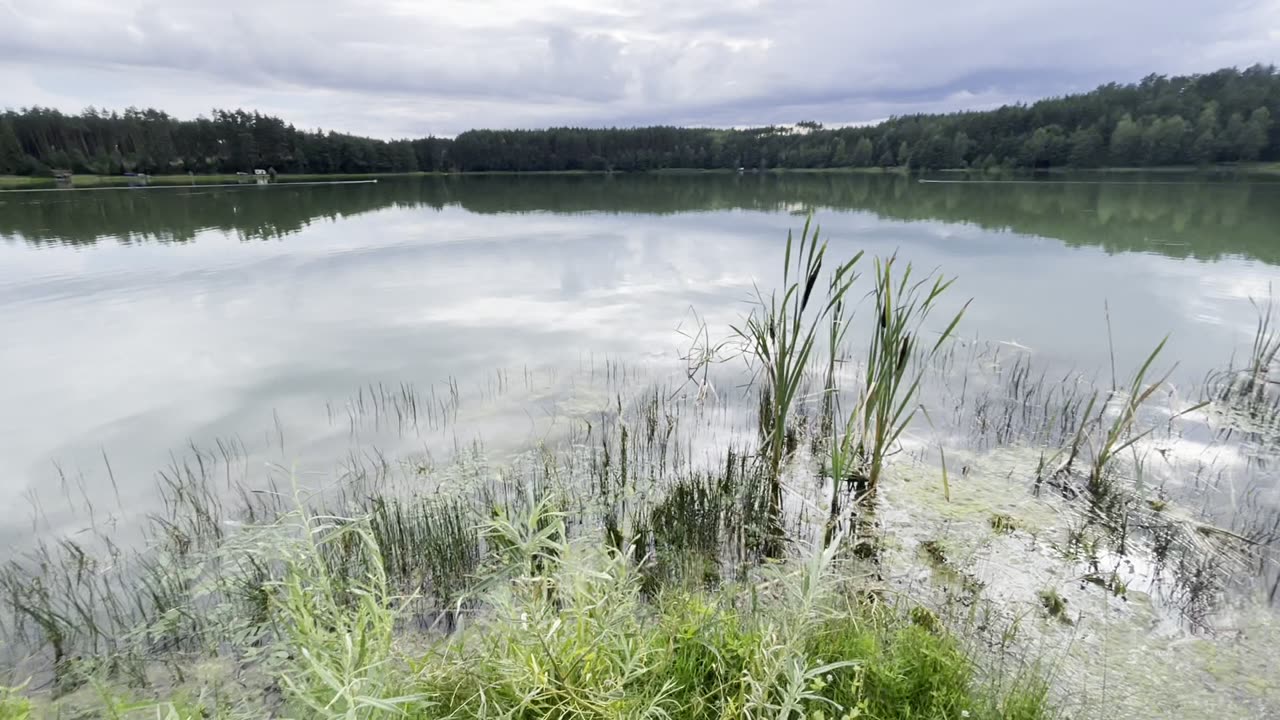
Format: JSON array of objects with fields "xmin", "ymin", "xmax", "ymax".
[{"xmin": 0, "ymin": 0, "xmax": 1280, "ymax": 137}]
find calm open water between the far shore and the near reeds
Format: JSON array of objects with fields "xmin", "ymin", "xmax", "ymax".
[{"xmin": 0, "ymin": 176, "xmax": 1280, "ymax": 542}]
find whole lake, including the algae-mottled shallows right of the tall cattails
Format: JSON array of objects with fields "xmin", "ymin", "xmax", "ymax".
[{"xmin": 0, "ymin": 173, "xmax": 1280, "ymax": 717}]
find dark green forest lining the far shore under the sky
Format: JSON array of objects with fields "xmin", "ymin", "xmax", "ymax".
[{"xmin": 0, "ymin": 65, "xmax": 1280, "ymax": 176}]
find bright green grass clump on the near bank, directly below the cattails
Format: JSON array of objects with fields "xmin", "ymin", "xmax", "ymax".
[{"xmin": 415, "ymin": 512, "xmax": 1047, "ymax": 720}]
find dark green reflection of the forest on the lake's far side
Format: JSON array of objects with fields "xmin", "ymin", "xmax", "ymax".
[{"xmin": 0, "ymin": 174, "xmax": 1280, "ymax": 264}]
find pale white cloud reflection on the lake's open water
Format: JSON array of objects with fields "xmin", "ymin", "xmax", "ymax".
[{"xmin": 0, "ymin": 196, "xmax": 1266, "ymax": 538}]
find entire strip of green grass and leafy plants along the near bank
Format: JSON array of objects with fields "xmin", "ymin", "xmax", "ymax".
[{"xmin": 10, "ymin": 488, "xmax": 1050, "ymax": 720}]
